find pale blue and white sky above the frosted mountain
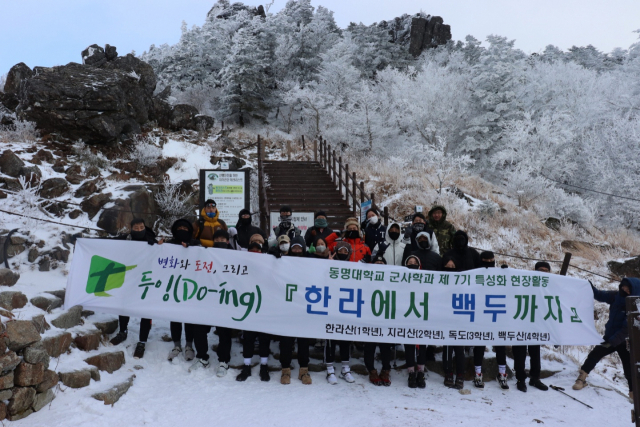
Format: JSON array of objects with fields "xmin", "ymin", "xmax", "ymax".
[{"xmin": 0, "ymin": 0, "xmax": 640, "ymax": 74}]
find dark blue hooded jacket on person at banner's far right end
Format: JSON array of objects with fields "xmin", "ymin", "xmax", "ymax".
[{"xmin": 591, "ymin": 277, "xmax": 640, "ymax": 347}]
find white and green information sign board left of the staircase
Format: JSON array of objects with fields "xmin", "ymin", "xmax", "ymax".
[{"xmin": 202, "ymin": 170, "xmax": 249, "ymax": 226}]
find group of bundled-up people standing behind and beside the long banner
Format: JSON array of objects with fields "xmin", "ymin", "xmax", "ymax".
[{"xmin": 105, "ymin": 200, "xmax": 640, "ymax": 394}]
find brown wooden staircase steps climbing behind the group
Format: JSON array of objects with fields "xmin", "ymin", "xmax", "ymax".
[{"xmin": 264, "ymin": 160, "xmax": 353, "ymax": 230}]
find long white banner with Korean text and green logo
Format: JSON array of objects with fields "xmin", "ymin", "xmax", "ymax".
[{"xmin": 65, "ymin": 239, "xmax": 602, "ymax": 345}]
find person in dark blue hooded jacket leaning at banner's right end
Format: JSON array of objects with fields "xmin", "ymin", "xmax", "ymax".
[{"xmin": 573, "ymin": 277, "xmax": 640, "ymax": 399}]
